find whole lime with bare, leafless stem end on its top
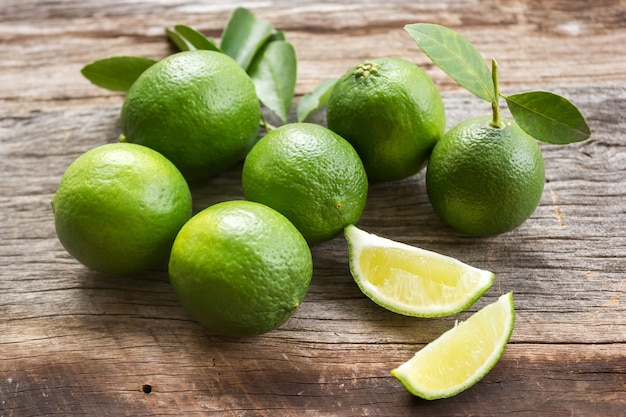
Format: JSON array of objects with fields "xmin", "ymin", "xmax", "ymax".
[{"xmin": 326, "ymin": 57, "xmax": 446, "ymax": 181}]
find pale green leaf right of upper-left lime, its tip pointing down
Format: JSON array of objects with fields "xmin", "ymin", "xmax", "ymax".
[{"xmin": 248, "ymin": 41, "xmax": 297, "ymax": 123}]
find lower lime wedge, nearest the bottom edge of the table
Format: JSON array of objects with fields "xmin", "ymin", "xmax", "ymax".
[{"xmin": 391, "ymin": 293, "xmax": 515, "ymax": 400}]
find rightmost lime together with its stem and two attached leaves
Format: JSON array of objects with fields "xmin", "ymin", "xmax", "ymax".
[{"xmin": 405, "ymin": 23, "xmax": 590, "ymax": 236}]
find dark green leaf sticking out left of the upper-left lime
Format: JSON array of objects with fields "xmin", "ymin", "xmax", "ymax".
[{"xmin": 80, "ymin": 56, "xmax": 157, "ymax": 91}]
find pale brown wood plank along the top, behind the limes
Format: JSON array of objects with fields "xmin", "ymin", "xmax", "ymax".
[{"xmin": 0, "ymin": 0, "xmax": 626, "ymax": 106}]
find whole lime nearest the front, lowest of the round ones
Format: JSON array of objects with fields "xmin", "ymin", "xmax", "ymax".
[{"xmin": 169, "ymin": 201, "xmax": 313, "ymax": 336}]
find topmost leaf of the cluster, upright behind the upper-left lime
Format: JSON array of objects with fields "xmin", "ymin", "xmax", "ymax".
[{"xmin": 220, "ymin": 7, "xmax": 275, "ymax": 70}]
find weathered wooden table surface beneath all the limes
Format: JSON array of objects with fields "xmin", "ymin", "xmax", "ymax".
[{"xmin": 0, "ymin": 0, "xmax": 626, "ymax": 417}]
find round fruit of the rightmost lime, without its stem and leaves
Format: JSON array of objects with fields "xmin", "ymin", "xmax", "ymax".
[{"xmin": 426, "ymin": 117, "xmax": 544, "ymax": 236}]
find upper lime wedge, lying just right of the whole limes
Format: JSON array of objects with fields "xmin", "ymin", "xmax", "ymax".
[{"xmin": 344, "ymin": 225, "xmax": 494, "ymax": 317}]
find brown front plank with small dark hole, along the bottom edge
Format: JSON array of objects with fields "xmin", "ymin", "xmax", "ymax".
[{"xmin": 3, "ymin": 338, "xmax": 625, "ymax": 416}]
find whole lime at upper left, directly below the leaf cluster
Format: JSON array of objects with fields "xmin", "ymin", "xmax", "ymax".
[{"xmin": 121, "ymin": 50, "xmax": 261, "ymax": 180}]
